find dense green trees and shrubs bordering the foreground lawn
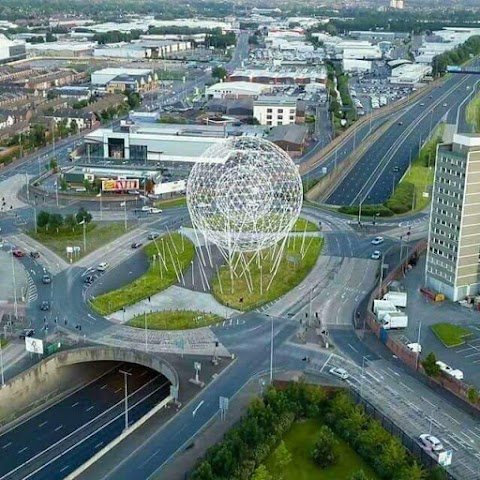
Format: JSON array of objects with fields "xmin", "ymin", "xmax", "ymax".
[{"xmin": 190, "ymin": 383, "xmax": 445, "ymax": 480}]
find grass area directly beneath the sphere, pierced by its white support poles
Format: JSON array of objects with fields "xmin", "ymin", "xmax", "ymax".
[{"xmin": 212, "ymin": 236, "xmax": 323, "ymax": 311}]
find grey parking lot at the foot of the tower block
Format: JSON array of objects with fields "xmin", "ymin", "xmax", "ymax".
[{"xmin": 389, "ymin": 256, "xmax": 480, "ymax": 388}]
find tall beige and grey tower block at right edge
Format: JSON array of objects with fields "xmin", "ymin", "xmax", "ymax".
[{"xmin": 425, "ymin": 134, "xmax": 480, "ymax": 301}]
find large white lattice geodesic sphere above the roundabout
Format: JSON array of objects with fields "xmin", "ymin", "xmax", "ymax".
[{"xmin": 187, "ymin": 137, "xmax": 303, "ymax": 252}]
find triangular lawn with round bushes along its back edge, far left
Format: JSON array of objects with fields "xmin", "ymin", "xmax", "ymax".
[{"xmin": 28, "ymin": 222, "xmax": 125, "ymax": 262}]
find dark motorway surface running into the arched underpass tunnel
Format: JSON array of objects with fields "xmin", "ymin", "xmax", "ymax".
[{"xmin": 0, "ymin": 364, "xmax": 170, "ymax": 480}]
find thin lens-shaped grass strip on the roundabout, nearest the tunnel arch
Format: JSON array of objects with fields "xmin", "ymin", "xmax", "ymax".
[{"xmin": 127, "ymin": 310, "xmax": 223, "ymax": 330}]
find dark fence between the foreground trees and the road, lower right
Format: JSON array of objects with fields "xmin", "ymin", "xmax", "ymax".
[{"xmin": 349, "ymin": 390, "xmax": 460, "ymax": 480}]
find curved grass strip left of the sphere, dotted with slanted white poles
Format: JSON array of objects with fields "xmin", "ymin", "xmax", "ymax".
[{"xmin": 91, "ymin": 233, "xmax": 195, "ymax": 315}]
